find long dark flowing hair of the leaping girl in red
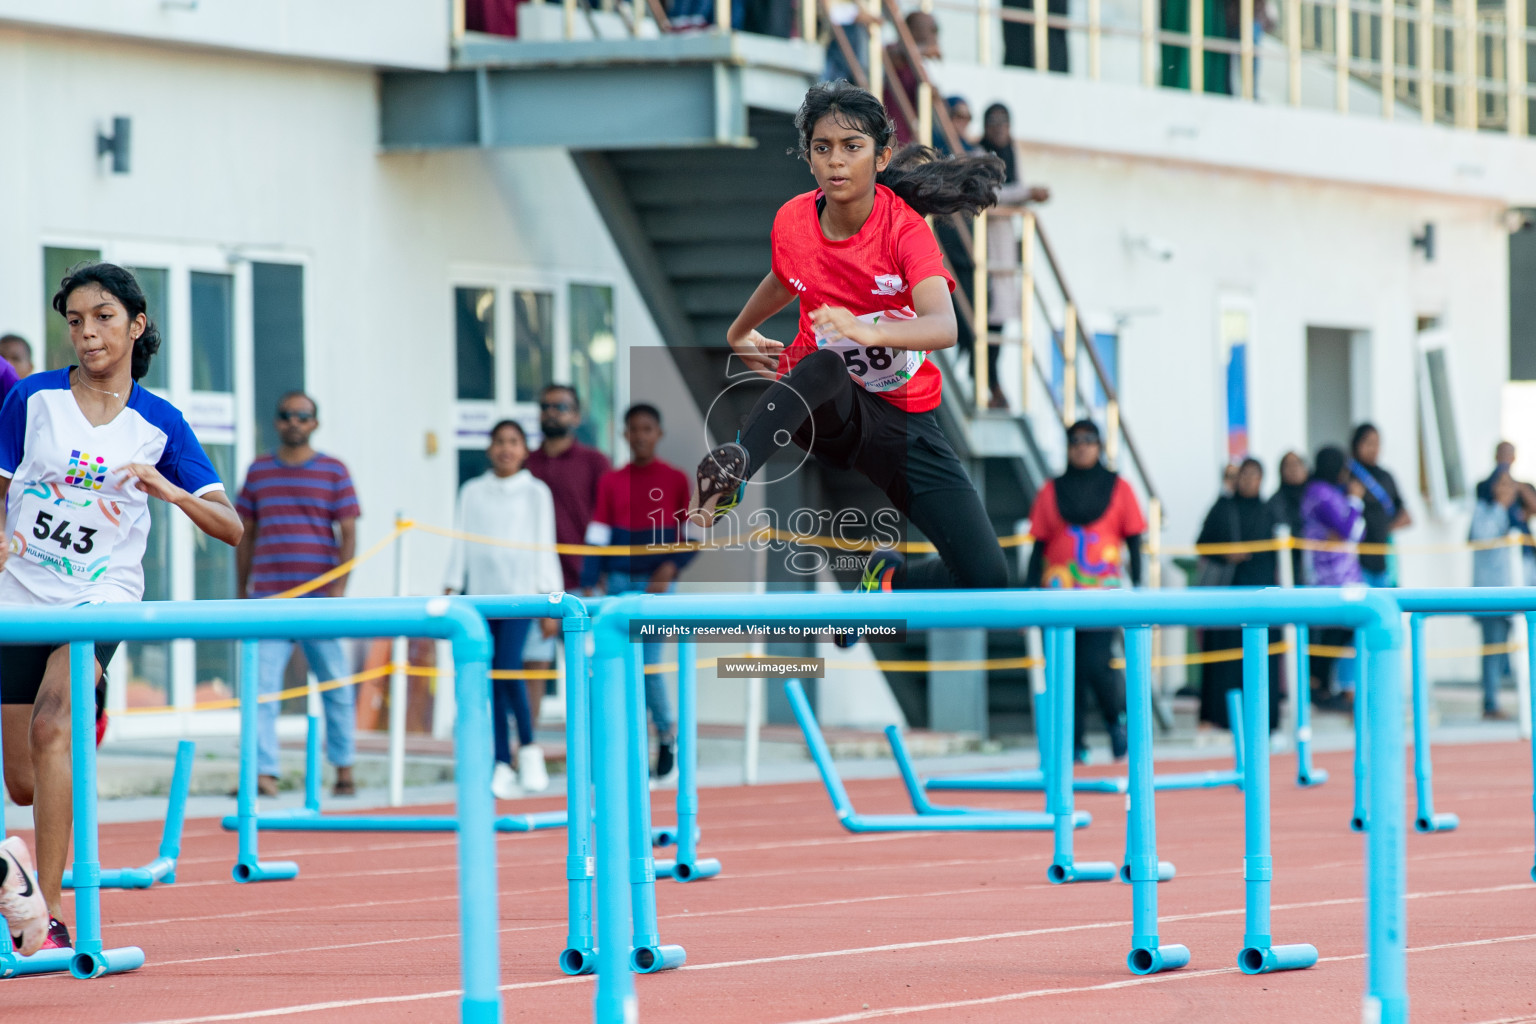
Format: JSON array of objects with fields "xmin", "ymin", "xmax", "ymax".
[{"xmin": 794, "ymin": 80, "xmax": 1005, "ymax": 216}]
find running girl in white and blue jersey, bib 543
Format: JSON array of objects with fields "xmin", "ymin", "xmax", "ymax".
[{"xmin": 0, "ymin": 263, "xmax": 241, "ymax": 953}]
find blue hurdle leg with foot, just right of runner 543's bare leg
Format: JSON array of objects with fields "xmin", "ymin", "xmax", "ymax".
[{"xmin": 69, "ymin": 640, "xmax": 144, "ymax": 979}]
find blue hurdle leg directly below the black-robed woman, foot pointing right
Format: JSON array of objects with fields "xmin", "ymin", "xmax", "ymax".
[{"xmin": 1238, "ymin": 626, "xmax": 1320, "ymax": 975}]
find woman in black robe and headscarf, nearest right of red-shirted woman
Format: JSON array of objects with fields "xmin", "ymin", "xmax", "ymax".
[{"xmin": 1195, "ymin": 459, "xmax": 1286, "ymax": 731}]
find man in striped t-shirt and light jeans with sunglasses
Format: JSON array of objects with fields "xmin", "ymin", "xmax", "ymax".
[{"xmin": 235, "ymin": 391, "xmax": 361, "ymax": 797}]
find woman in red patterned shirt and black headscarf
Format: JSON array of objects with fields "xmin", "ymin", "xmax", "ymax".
[{"xmin": 1025, "ymin": 419, "xmax": 1147, "ymax": 761}]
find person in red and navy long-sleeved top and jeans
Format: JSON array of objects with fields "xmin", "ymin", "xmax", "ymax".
[{"xmin": 581, "ymin": 402, "xmax": 693, "ymax": 778}]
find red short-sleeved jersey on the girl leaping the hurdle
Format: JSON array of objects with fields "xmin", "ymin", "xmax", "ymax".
[{"xmin": 773, "ymin": 184, "xmax": 955, "ymax": 413}]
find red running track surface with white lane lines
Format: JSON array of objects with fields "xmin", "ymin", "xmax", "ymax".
[{"xmin": 0, "ymin": 743, "xmax": 1536, "ymax": 1024}]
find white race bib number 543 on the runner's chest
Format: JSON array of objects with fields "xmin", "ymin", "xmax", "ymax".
[{"xmin": 8, "ymin": 484, "xmax": 121, "ymax": 580}]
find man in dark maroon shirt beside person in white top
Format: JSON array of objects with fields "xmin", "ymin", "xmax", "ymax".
[{"xmin": 522, "ymin": 384, "xmax": 613, "ymax": 723}]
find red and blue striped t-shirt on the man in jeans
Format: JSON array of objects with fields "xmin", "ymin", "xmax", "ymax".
[{"xmin": 235, "ymin": 454, "xmax": 362, "ymax": 597}]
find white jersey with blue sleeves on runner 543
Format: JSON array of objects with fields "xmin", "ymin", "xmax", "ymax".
[{"xmin": 0, "ymin": 367, "xmax": 224, "ymax": 605}]
